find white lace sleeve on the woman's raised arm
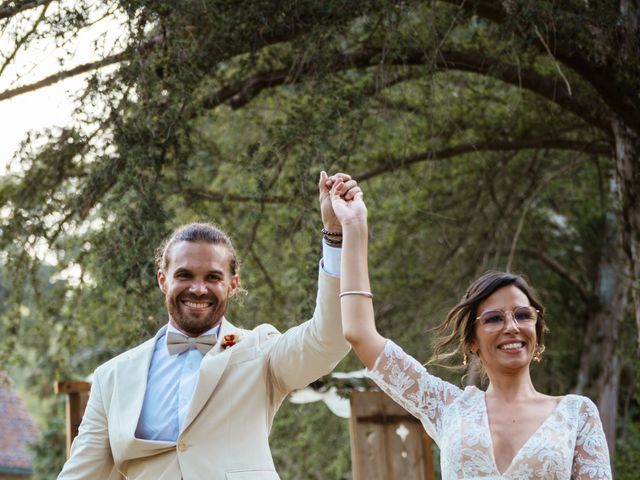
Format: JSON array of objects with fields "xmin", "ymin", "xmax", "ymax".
[{"xmin": 367, "ymin": 340, "xmax": 462, "ymax": 442}]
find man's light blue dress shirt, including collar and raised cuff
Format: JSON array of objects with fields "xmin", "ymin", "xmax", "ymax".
[{"xmin": 136, "ymin": 242, "xmax": 341, "ymax": 442}]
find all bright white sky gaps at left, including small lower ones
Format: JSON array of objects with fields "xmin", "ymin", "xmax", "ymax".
[{"xmin": 0, "ymin": 0, "xmax": 126, "ymax": 278}]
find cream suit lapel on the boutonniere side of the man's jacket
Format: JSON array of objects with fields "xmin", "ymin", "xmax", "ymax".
[{"xmin": 180, "ymin": 318, "xmax": 236, "ymax": 434}]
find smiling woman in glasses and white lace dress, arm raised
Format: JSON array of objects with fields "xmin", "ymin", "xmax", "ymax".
[{"xmin": 331, "ymin": 181, "xmax": 611, "ymax": 480}]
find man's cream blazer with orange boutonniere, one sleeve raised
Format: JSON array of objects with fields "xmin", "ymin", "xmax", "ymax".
[{"xmin": 58, "ymin": 269, "xmax": 349, "ymax": 480}]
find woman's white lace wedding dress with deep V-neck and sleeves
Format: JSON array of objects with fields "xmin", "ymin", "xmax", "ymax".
[{"xmin": 367, "ymin": 340, "xmax": 612, "ymax": 480}]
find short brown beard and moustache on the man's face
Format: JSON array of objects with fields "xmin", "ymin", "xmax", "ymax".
[{"xmin": 165, "ymin": 294, "xmax": 229, "ymax": 336}]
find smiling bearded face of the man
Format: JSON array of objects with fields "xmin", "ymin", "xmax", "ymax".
[{"xmin": 157, "ymin": 241, "xmax": 238, "ymax": 336}]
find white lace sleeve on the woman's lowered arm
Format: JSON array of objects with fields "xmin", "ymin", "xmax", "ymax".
[{"xmin": 573, "ymin": 398, "xmax": 613, "ymax": 480}]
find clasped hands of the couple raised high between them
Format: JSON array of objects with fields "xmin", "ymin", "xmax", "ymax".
[{"xmin": 318, "ymin": 171, "xmax": 367, "ymax": 232}]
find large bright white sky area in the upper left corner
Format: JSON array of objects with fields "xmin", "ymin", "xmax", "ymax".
[{"xmin": 0, "ymin": 0, "xmax": 122, "ymax": 175}]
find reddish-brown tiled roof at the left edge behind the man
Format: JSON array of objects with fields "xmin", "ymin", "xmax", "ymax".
[{"xmin": 0, "ymin": 372, "xmax": 38, "ymax": 470}]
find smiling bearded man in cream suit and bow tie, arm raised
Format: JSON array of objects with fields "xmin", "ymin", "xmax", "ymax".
[{"xmin": 58, "ymin": 172, "xmax": 360, "ymax": 480}]
